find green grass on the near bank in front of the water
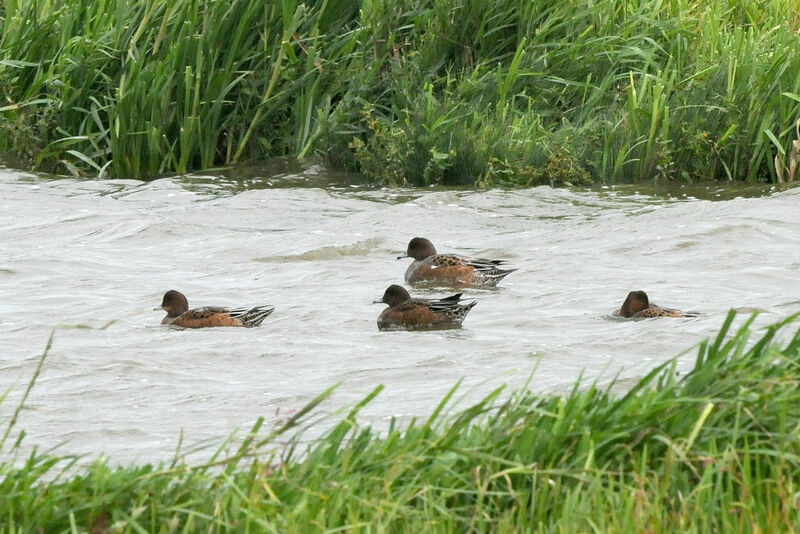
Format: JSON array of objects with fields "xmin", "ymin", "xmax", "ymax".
[{"xmin": 0, "ymin": 312, "xmax": 800, "ymax": 533}]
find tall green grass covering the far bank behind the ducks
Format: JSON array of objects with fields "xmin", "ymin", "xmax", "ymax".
[{"xmin": 0, "ymin": 0, "xmax": 800, "ymax": 186}]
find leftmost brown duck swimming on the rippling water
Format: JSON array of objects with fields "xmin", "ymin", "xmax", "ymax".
[{"xmin": 155, "ymin": 289, "xmax": 275, "ymax": 328}]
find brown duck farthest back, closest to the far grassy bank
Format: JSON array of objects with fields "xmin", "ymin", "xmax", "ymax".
[{"xmin": 397, "ymin": 237, "xmax": 516, "ymax": 287}]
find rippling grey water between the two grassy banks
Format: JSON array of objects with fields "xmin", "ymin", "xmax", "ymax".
[{"xmin": 0, "ymin": 161, "xmax": 800, "ymax": 463}]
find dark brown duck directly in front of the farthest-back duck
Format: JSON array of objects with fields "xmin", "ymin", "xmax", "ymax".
[{"xmin": 375, "ymin": 284, "xmax": 477, "ymax": 330}]
